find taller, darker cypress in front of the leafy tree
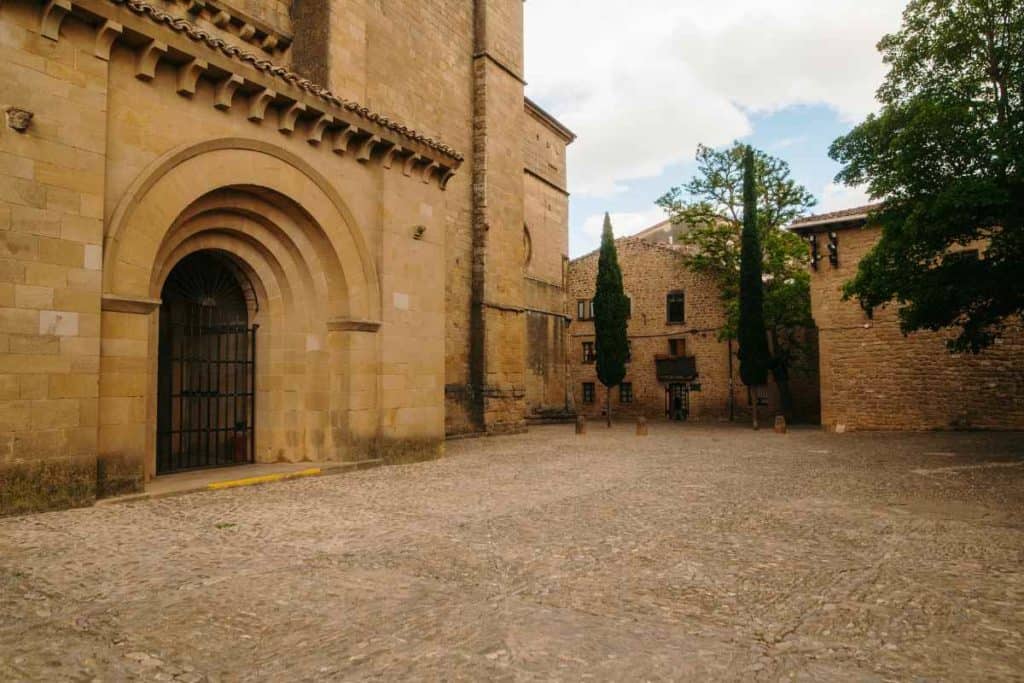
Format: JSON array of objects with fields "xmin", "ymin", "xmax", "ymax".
[{"xmin": 736, "ymin": 146, "xmax": 771, "ymax": 429}]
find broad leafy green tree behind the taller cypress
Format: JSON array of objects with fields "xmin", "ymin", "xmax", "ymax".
[{"xmin": 657, "ymin": 142, "xmax": 815, "ymax": 417}]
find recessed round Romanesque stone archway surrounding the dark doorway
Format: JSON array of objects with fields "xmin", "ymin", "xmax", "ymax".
[{"xmin": 100, "ymin": 140, "xmax": 380, "ymax": 476}]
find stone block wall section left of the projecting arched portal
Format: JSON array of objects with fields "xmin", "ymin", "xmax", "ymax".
[{"xmin": 0, "ymin": 2, "xmax": 106, "ymax": 514}]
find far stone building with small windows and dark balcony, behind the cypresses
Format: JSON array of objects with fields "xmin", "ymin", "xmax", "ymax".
[{"xmin": 568, "ymin": 237, "xmax": 817, "ymax": 421}]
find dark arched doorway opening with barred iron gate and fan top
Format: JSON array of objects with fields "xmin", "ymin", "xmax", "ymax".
[{"xmin": 157, "ymin": 251, "xmax": 259, "ymax": 475}]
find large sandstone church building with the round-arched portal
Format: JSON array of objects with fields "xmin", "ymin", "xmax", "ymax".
[{"xmin": 0, "ymin": 0, "xmax": 572, "ymax": 514}]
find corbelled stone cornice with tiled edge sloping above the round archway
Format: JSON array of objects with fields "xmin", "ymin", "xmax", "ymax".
[{"xmin": 40, "ymin": 0, "xmax": 463, "ymax": 189}]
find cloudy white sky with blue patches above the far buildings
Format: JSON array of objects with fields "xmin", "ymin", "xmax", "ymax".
[{"xmin": 524, "ymin": 0, "xmax": 906, "ymax": 257}]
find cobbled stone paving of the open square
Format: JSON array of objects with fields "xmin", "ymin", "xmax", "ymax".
[{"xmin": 0, "ymin": 424, "xmax": 1024, "ymax": 682}]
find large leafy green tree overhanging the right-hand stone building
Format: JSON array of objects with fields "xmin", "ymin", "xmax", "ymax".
[{"xmin": 830, "ymin": 0, "xmax": 1024, "ymax": 352}]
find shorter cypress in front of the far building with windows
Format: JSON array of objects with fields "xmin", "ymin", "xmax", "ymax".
[{"xmin": 594, "ymin": 214, "xmax": 630, "ymax": 427}]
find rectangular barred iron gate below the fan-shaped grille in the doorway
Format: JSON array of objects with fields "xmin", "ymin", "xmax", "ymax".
[{"xmin": 157, "ymin": 322, "xmax": 259, "ymax": 474}]
